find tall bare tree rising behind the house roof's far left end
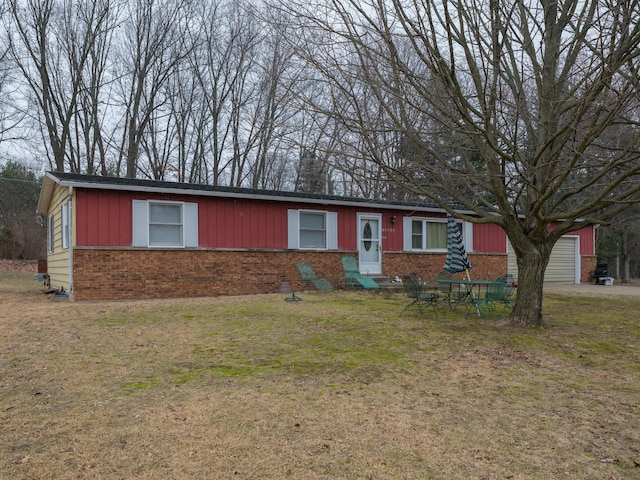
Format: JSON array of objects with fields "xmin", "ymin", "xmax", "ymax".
[{"xmin": 9, "ymin": 0, "xmax": 109, "ymax": 171}]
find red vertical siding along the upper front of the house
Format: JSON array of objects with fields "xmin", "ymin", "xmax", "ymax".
[{"xmin": 76, "ymin": 188, "xmax": 520, "ymax": 255}]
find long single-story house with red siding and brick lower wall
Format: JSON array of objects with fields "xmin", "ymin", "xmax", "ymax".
[{"xmin": 38, "ymin": 173, "xmax": 595, "ymax": 300}]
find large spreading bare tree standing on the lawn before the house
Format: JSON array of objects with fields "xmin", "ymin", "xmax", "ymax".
[{"xmin": 272, "ymin": 0, "xmax": 640, "ymax": 326}]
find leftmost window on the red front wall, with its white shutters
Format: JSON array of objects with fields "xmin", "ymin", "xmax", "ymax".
[{"xmin": 133, "ymin": 200, "xmax": 198, "ymax": 248}]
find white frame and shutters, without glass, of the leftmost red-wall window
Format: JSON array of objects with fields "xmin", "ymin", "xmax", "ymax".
[{"xmin": 132, "ymin": 200, "xmax": 198, "ymax": 248}]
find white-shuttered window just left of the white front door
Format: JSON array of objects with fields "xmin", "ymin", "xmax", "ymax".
[{"xmin": 288, "ymin": 210, "xmax": 338, "ymax": 250}]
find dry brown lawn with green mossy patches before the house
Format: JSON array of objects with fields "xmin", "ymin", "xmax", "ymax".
[{"xmin": 0, "ymin": 273, "xmax": 640, "ymax": 480}]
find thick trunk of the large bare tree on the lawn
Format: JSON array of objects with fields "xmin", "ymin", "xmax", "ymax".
[{"xmin": 508, "ymin": 242, "xmax": 553, "ymax": 327}]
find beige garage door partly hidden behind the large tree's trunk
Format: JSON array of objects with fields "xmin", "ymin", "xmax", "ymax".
[{"xmin": 508, "ymin": 237, "xmax": 580, "ymax": 283}]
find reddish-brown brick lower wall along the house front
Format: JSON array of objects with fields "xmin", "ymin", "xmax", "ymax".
[{"xmin": 73, "ymin": 248, "xmax": 507, "ymax": 300}]
